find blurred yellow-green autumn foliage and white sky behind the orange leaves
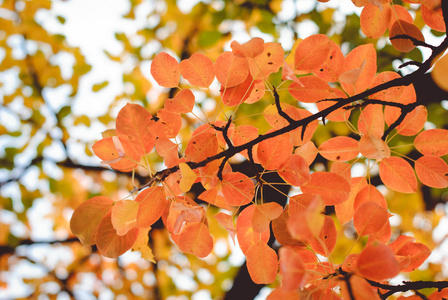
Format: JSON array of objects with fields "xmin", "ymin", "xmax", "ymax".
[{"xmin": 0, "ymin": 0, "xmax": 448, "ymax": 299}]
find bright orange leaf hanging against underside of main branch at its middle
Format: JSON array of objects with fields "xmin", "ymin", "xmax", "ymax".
[{"xmin": 257, "ymin": 134, "xmax": 293, "ymax": 170}]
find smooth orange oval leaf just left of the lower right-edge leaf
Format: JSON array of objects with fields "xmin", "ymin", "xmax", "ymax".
[{"xmin": 380, "ymin": 156, "xmax": 417, "ymax": 193}]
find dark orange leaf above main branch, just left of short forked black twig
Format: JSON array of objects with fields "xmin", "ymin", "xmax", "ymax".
[{"xmin": 185, "ymin": 129, "xmax": 219, "ymax": 162}]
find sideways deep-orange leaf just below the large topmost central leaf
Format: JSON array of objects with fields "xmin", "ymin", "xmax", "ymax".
[{"xmin": 288, "ymin": 75, "xmax": 333, "ymax": 103}]
